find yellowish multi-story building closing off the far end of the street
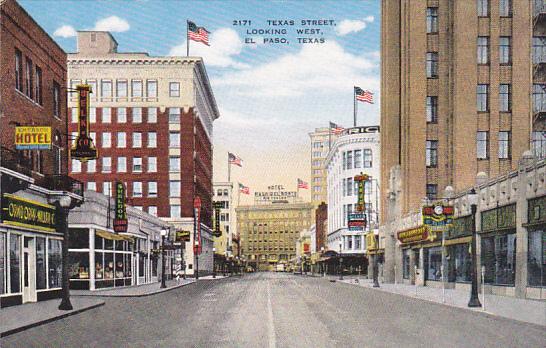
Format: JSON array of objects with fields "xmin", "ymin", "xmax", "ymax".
[{"xmin": 235, "ymin": 203, "xmax": 314, "ymax": 271}]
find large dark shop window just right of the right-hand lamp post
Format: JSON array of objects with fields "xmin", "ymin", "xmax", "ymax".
[{"xmin": 481, "ymin": 233, "xmax": 516, "ymax": 285}]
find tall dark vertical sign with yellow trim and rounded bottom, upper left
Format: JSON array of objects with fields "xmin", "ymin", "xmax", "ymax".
[{"xmin": 70, "ymin": 85, "xmax": 97, "ymax": 162}]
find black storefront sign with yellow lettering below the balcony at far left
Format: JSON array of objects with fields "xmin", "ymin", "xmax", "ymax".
[{"xmin": 1, "ymin": 193, "xmax": 55, "ymax": 232}]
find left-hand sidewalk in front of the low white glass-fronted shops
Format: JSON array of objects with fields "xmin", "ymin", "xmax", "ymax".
[{"xmin": 70, "ymin": 278, "xmax": 195, "ymax": 297}]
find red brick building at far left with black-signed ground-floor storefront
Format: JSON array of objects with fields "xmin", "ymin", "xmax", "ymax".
[{"xmin": 0, "ymin": 0, "xmax": 83, "ymax": 307}]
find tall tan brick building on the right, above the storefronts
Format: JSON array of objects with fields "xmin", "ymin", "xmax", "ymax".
[{"xmin": 381, "ymin": 0, "xmax": 546, "ymax": 221}]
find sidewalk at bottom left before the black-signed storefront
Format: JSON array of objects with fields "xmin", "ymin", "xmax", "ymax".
[{"xmin": 0, "ymin": 297, "xmax": 104, "ymax": 337}]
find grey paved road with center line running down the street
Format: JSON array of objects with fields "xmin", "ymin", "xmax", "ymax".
[{"xmin": 0, "ymin": 273, "xmax": 546, "ymax": 348}]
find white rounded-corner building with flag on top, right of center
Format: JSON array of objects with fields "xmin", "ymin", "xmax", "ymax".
[{"xmin": 325, "ymin": 126, "xmax": 380, "ymax": 256}]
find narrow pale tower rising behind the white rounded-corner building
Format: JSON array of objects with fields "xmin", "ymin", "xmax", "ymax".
[{"xmin": 309, "ymin": 127, "xmax": 337, "ymax": 207}]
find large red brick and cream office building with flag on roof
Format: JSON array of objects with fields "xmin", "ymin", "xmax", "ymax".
[{"xmin": 68, "ymin": 31, "xmax": 219, "ymax": 274}]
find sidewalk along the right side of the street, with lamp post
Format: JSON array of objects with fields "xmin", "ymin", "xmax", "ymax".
[{"xmin": 338, "ymin": 277, "xmax": 546, "ymax": 326}]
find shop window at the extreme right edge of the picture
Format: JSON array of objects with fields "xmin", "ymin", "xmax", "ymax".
[{"xmin": 527, "ymin": 230, "xmax": 546, "ymax": 286}]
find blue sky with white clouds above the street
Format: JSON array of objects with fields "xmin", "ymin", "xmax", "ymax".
[{"xmin": 19, "ymin": 0, "xmax": 381, "ymax": 204}]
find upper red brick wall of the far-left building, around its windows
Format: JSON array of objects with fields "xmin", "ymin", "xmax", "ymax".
[{"xmin": 0, "ymin": 0, "xmax": 68, "ymax": 179}]
